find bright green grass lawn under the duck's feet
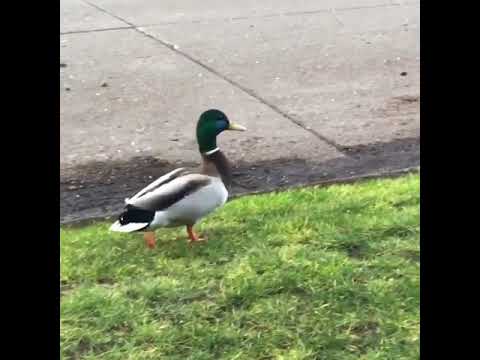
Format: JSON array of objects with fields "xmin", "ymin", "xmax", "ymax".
[{"xmin": 61, "ymin": 175, "xmax": 420, "ymax": 360}]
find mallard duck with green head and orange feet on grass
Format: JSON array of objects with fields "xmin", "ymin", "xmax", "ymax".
[{"xmin": 110, "ymin": 109, "xmax": 246, "ymax": 248}]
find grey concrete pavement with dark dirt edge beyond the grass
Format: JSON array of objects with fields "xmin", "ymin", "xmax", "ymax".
[{"xmin": 60, "ymin": 0, "xmax": 420, "ymax": 221}]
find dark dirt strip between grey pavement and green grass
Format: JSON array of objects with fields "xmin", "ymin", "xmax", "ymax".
[{"xmin": 60, "ymin": 139, "xmax": 420, "ymax": 224}]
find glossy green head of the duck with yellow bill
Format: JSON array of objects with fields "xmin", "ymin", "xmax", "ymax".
[{"xmin": 197, "ymin": 109, "xmax": 246, "ymax": 153}]
